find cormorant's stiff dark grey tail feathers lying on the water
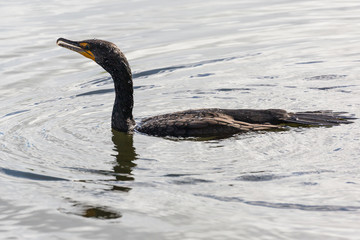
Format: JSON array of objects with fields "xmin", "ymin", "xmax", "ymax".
[{"xmin": 283, "ymin": 110, "xmax": 356, "ymax": 126}]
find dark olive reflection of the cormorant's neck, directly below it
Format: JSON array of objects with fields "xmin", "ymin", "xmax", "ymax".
[{"xmin": 112, "ymin": 130, "xmax": 137, "ymax": 192}]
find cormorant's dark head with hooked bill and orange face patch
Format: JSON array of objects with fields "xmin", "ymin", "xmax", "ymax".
[{"xmin": 56, "ymin": 38, "xmax": 130, "ymax": 74}]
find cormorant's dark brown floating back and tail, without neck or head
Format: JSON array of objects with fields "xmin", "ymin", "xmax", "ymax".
[{"xmin": 136, "ymin": 108, "xmax": 349, "ymax": 137}]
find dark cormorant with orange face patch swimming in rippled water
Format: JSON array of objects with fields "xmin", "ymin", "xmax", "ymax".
[{"xmin": 57, "ymin": 38, "xmax": 354, "ymax": 137}]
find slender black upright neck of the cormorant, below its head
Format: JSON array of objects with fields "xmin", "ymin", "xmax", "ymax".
[{"xmin": 109, "ymin": 59, "xmax": 135, "ymax": 132}]
